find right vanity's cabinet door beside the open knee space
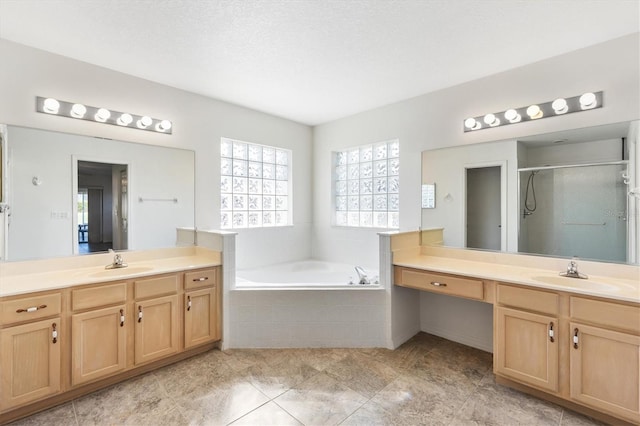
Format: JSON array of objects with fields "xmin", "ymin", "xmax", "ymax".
[{"xmin": 494, "ymin": 307, "xmax": 558, "ymax": 392}]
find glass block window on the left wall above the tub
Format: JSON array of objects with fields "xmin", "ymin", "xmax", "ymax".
[{"xmin": 220, "ymin": 138, "xmax": 291, "ymax": 229}]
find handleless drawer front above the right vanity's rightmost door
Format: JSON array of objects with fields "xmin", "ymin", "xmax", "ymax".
[{"xmin": 570, "ymin": 296, "xmax": 640, "ymax": 334}]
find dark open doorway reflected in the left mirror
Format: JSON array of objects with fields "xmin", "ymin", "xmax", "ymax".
[{"xmin": 74, "ymin": 160, "xmax": 128, "ymax": 253}]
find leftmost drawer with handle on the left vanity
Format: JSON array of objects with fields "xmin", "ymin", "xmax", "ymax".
[{"xmin": 0, "ymin": 293, "xmax": 62, "ymax": 325}]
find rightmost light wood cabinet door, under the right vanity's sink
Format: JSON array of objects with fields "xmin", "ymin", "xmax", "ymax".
[{"xmin": 570, "ymin": 323, "xmax": 640, "ymax": 423}]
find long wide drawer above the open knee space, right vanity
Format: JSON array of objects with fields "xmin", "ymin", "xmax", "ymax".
[{"xmin": 395, "ymin": 266, "xmax": 484, "ymax": 300}]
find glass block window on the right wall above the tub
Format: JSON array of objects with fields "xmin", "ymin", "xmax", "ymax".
[{"xmin": 333, "ymin": 139, "xmax": 400, "ymax": 229}]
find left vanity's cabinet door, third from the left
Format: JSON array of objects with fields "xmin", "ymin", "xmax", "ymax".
[{"xmin": 135, "ymin": 295, "xmax": 180, "ymax": 364}]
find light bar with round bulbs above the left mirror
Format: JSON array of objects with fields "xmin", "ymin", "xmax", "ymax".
[{"xmin": 36, "ymin": 96, "xmax": 173, "ymax": 135}]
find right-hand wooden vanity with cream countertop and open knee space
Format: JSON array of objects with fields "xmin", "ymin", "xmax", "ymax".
[{"xmin": 393, "ymin": 237, "xmax": 640, "ymax": 424}]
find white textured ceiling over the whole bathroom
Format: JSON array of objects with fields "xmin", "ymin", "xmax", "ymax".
[{"xmin": 0, "ymin": 0, "xmax": 640, "ymax": 125}]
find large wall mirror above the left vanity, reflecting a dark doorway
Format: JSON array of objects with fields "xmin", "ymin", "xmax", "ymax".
[{"xmin": 4, "ymin": 126, "xmax": 195, "ymax": 261}]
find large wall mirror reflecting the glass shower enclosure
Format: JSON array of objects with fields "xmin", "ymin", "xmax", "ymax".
[{"xmin": 422, "ymin": 121, "xmax": 640, "ymax": 263}]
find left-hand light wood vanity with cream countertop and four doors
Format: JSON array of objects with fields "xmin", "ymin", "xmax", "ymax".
[{"xmin": 0, "ymin": 247, "xmax": 222, "ymax": 424}]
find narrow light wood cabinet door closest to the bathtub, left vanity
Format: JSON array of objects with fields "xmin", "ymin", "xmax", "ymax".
[{"xmin": 184, "ymin": 287, "xmax": 220, "ymax": 348}]
